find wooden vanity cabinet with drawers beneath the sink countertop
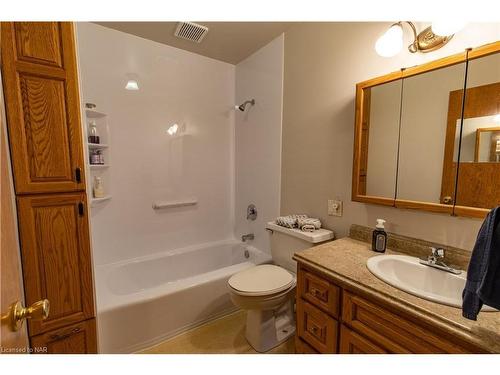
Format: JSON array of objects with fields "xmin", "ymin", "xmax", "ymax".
[{"xmin": 296, "ymin": 263, "xmax": 482, "ymax": 354}]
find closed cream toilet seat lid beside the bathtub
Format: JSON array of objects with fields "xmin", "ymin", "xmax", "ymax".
[{"xmin": 228, "ymin": 264, "xmax": 296, "ymax": 297}]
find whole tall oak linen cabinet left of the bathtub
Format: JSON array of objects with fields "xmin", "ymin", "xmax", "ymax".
[{"xmin": 1, "ymin": 22, "xmax": 97, "ymax": 353}]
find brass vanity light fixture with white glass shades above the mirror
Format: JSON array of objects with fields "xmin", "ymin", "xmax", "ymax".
[{"xmin": 375, "ymin": 21, "xmax": 463, "ymax": 57}]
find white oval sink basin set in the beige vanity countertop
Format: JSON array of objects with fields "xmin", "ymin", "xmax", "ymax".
[{"xmin": 366, "ymin": 255, "xmax": 497, "ymax": 311}]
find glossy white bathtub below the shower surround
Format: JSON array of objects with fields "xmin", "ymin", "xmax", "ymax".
[{"xmin": 95, "ymin": 241, "xmax": 271, "ymax": 353}]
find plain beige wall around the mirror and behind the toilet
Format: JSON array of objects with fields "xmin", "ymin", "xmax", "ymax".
[{"xmin": 281, "ymin": 23, "xmax": 500, "ymax": 249}]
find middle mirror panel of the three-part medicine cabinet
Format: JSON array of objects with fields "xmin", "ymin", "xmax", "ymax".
[{"xmin": 396, "ymin": 61, "xmax": 466, "ymax": 213}]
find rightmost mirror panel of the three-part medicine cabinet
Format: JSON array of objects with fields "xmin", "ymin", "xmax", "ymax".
[{"xmin": 455, "ymin": 53, "xmax": 500, "ymax": 213}]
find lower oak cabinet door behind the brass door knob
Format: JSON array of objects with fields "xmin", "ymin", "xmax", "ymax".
[{"xmin": 17, "ymin": 193, "xmax": 94, "ymax": 336}]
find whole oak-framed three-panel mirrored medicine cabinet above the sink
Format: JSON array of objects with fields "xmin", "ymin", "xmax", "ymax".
[{"xmin": 352, "ymin": 42, "xmax": 500, "ymax": 217}]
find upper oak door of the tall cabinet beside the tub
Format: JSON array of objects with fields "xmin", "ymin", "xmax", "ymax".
[{"xmin": 1, "ymin": 22, "xmax": 85, "ymax": 194}]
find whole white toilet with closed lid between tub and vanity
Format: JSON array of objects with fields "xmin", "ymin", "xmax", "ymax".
[{"xmin": 228, "ymin": 222, "xmax": 334, "ymax": 353}]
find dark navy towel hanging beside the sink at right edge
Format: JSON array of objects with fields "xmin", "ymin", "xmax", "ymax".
[{"xmin": 462, "ymin": 206, "xmax": 500, "ymax": 320}]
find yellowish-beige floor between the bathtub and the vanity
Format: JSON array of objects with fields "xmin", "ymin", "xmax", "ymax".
[{"xmin": 139, "ymin": 311, "xmax": 295, "ymax": 354}]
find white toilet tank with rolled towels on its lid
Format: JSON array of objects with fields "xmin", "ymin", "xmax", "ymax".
[{"xmin": 266, "ymin": 222, "xmax": 334, "ymax": 273}]
